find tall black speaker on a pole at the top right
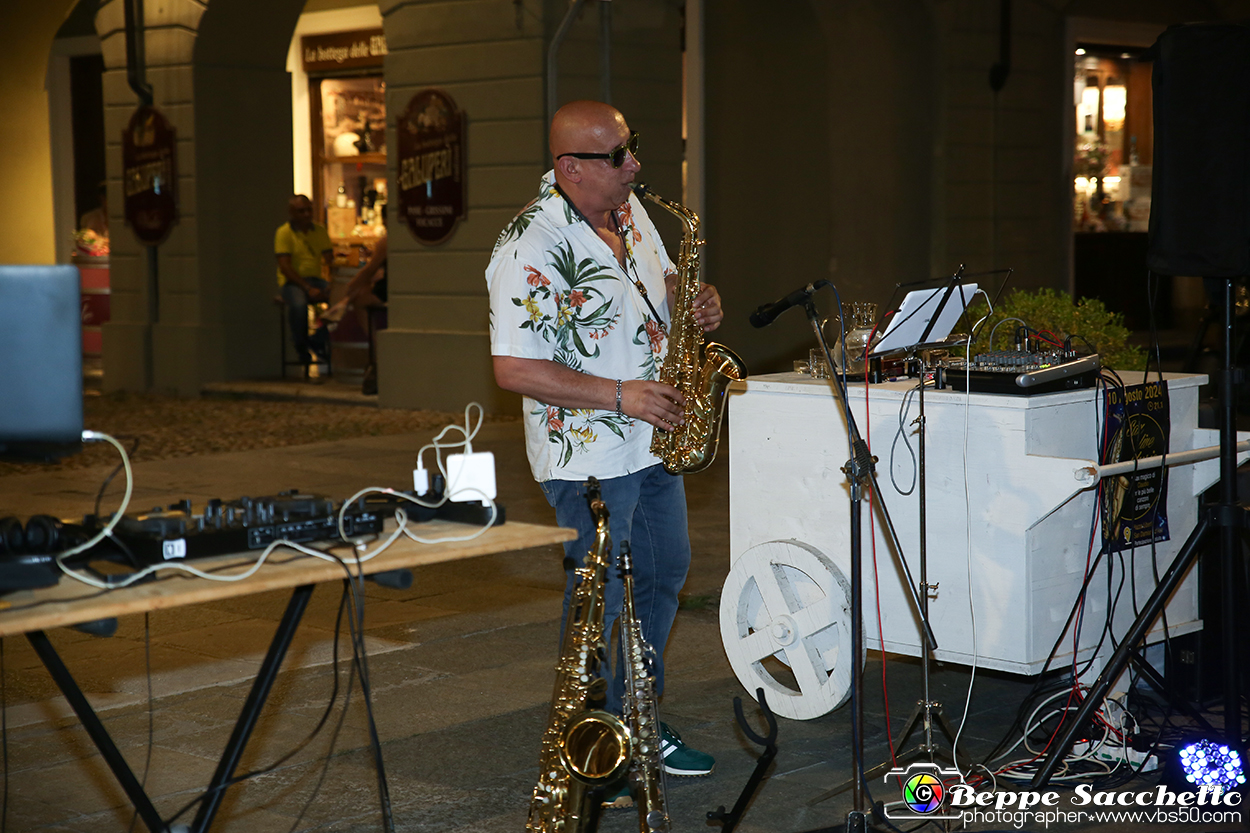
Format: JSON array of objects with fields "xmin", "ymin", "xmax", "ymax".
[{"xmin": 1146, "ymin": 24, "xmax": 1250, "ymax": 278}]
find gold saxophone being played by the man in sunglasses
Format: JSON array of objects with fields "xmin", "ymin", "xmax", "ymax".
[{"xmin": 634, "ymin": 183, "xmax": 746, "ymax": 474}]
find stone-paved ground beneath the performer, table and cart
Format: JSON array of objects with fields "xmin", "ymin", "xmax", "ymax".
[{"xmin": 0, "ymin": 400, "xmax": 1231, "ymax": 833}]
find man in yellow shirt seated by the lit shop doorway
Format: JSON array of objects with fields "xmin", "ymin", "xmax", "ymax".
[{"xmin": 274, "ymin": 194, "xmax": 334, "ymax": 366}]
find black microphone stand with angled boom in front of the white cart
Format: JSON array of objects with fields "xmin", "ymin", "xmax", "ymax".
[{"xmin": 803, "ymin": 290, "xmax": 938, "ymax": 832}]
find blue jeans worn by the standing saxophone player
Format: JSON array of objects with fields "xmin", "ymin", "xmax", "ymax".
[{"xmin": 539, "ymin": 465, "xmax": 690, "ymax": 714}]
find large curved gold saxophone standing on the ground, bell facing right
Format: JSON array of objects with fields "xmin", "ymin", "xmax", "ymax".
[{"xmin": 525, "ymin": 478, "xmax": 630, "ymax": 833}]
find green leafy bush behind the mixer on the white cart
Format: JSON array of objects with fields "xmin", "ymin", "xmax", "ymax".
[{"xmin": 973, "ymin": 289, "xmax": 1146, "ymax": 370}]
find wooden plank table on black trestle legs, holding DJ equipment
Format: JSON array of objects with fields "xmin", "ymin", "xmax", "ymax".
[{"xmin": 0, "ymin": 520, "xmax": 576, "ymax": 833}]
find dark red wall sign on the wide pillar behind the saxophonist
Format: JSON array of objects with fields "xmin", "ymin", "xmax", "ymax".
[{"xmin": 395, "ymin": 90, "xmax": 465, "ymax": 245}]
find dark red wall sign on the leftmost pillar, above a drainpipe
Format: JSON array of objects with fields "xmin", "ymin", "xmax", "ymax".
[{"xmin": 121, "ymin": 106, "xmax": 178, "ymax": 246}]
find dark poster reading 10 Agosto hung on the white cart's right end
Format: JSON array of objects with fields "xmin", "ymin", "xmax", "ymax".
[{"xmin": 1103, "ymin": 381, "xmax": 1171, "ymax": 553}]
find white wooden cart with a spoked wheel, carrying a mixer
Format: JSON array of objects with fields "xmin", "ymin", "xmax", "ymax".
[{"xmin": 720, "ymin": 373, "xmax": 1245, "ymax": 719}]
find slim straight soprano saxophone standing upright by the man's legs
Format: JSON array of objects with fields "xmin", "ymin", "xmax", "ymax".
[{"xmin": 620, "ymin": 540, "xmax": 671, "ymax": 833}]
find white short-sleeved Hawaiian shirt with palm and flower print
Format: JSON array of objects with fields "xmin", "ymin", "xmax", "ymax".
[{"xmin": 486, "ymin": 171, "xmax": 673, "ymax": 482}]
